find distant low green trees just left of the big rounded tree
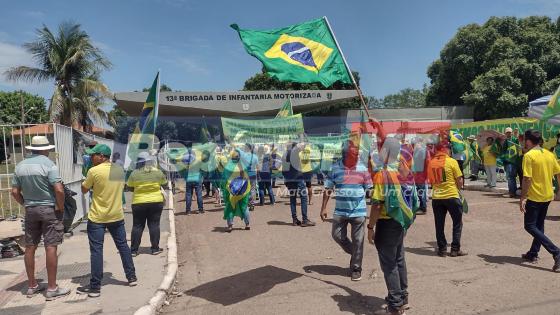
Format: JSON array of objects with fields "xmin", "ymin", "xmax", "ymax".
[{"xmin": 368, "ymin": 85, "xmax": 428, "ymax": 108}]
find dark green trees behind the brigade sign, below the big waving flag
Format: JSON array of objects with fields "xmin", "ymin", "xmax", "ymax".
[{"xmin": 243, "ymin": 69, "xmax": 361, "ymax": 116}]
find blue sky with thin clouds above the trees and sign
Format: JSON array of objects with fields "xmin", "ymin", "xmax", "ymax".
[{"xmin": 0, "ymin": 0, "xmax": 560, "ymax": 103}]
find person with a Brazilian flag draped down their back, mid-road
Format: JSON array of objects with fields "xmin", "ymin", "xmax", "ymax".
[{"xmin": 222, "ymin": 149, "xmax": 251, "ymax": 233}]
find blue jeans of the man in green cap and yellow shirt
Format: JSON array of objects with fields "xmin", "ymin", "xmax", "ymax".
[{"xmin": 87, "ymin": 220, "xmax": 136, "ymax": 289}]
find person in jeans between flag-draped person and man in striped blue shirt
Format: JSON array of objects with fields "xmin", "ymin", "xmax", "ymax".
[{"xmin": 282, "ymin": 142, "xmax": 315, "ymax": 227}]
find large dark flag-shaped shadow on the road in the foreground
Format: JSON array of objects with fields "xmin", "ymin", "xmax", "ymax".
[{"xmin": 185, "ymin": 266, "xmax": 302, "ymax": 306}]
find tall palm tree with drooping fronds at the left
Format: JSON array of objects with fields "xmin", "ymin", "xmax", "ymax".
[{"xmin": 5, "ymin": 22, "xmax": 111, "ymax": 128}]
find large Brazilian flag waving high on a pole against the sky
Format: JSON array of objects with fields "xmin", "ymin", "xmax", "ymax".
[{"xmin": 231, "ymin": 18, "xmax": 352, "ymax": 87}]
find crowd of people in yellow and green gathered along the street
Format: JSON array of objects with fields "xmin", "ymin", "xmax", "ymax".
[{"xmin": 12, "ymin": 121, "xmax": 560, "ymax": 314}]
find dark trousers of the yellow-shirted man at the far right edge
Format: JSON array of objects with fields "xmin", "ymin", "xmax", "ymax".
[{"xmin": 524, "ymin": 200, "xmax": 560, "ymax": 257}]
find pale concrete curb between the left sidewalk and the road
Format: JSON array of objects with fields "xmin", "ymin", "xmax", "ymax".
[{"xmin": 134, "ymin": 194, "xmax": 178, "ymax": 315}]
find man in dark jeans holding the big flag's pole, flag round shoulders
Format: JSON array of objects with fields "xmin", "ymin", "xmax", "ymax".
[{"xmin": 366, "ymin": 138, "xmax": 419, "ymax": 315}]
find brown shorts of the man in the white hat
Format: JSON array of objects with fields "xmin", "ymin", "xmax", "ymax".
[{"xmin": 24, "ymin": 206, "xmax": 64, "ymax": 247}]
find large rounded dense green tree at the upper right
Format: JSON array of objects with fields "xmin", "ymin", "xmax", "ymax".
[{"xmin": 427, "ymin": 16, "xmax": 560, "ymax": 120}]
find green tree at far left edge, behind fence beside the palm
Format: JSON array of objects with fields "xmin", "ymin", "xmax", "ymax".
[{"xmin": 0, "ymin": 91, "xmax": 49, "ymax": 124}]
